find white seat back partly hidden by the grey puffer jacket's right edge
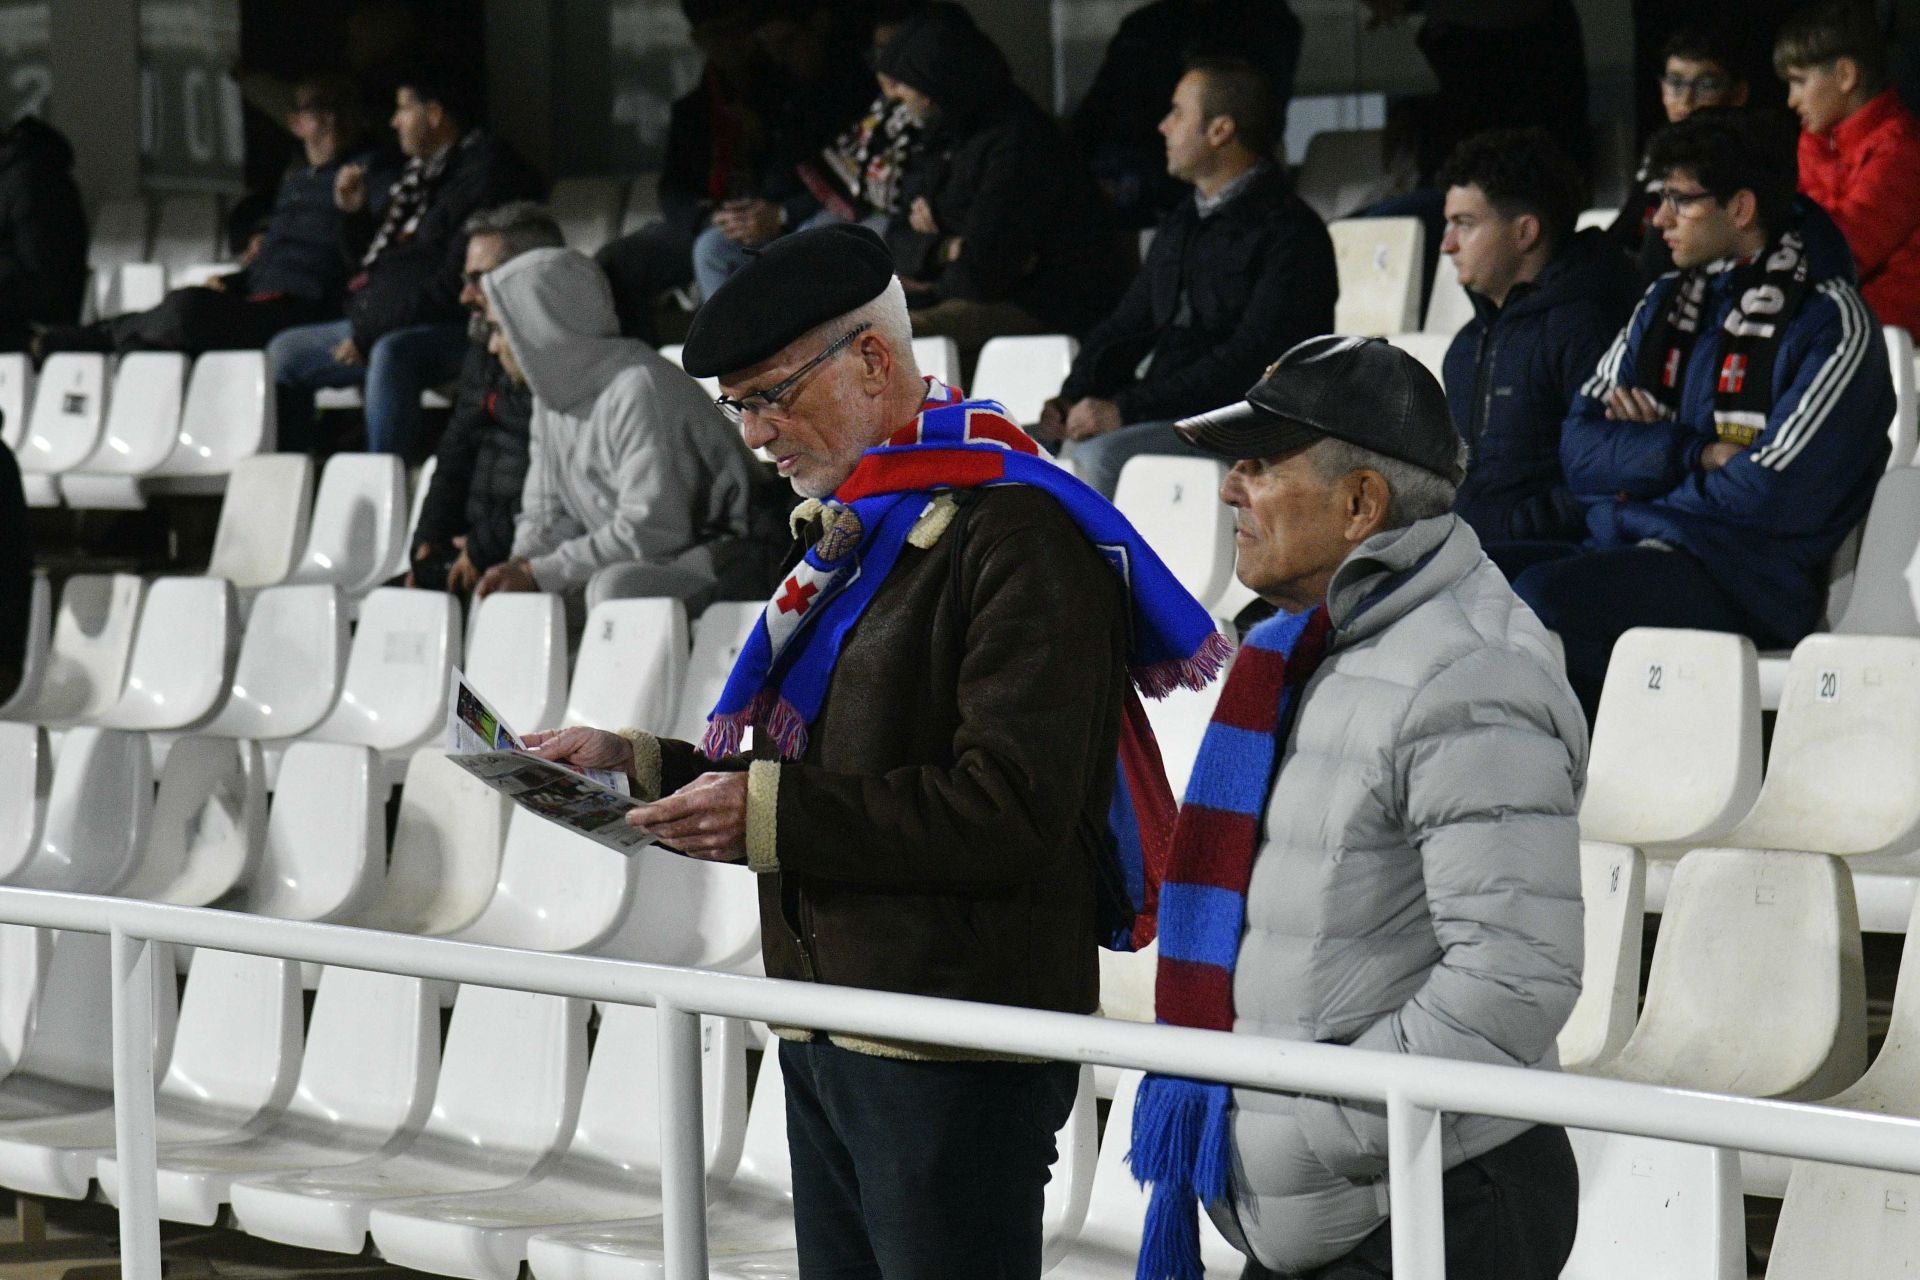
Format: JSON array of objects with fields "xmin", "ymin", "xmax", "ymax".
[{"xmin": 1557, "ymin": 841, "xmax": 1647, "ymax": 1071}]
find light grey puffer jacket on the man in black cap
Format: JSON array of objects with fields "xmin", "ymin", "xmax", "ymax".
[{"xmin": 1213, "ymin": 516, "xmax": 1586, "ymax": 1272}]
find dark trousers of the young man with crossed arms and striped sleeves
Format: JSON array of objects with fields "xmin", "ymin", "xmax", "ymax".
[{"xmin": 1486, "ymin": 543, "xmax": 1795, "ymax": 722}]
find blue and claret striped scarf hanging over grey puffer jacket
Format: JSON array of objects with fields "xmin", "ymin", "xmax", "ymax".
[{"xmin": 1127, "ymin": 604, "xmax": 1331, "ymax": 1280}]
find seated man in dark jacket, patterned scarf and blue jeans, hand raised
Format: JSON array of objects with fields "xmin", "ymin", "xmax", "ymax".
[{"xmin": 267, "ymin": 69, "xmax": 541, "ymax": 459}]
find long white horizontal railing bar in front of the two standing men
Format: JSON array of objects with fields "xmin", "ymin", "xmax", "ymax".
[{"xmin": 0, "ymin": 889, "xmax": 1920, "ymax": 1174}]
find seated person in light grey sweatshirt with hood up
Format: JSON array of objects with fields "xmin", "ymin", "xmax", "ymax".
[{"xmin": 474, "ymin": 249, "xmax": 753, "ymax": 622}]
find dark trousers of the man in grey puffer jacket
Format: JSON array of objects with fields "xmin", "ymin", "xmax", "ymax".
[{"xmin": 1240, "ymin": 1125, "xmax": 1580, "ymax": 1280}]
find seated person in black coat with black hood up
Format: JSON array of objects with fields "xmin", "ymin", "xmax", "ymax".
[{"xmin": 877, "ymin": 4, "xmax": 1133, "ymax": 379}]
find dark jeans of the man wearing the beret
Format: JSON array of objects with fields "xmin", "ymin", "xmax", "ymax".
[{"xmin": 780, "ymin": 1040, "xmax": 1079, "ymax": 1280}]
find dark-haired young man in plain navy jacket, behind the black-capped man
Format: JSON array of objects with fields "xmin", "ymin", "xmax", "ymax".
[{"xmin": 1438, "ymin": 129, "xmax": 1640, "ymax": 543}]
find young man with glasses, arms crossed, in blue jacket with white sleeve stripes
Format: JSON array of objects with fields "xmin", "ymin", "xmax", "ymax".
[{"xmin": 1490, "ymin": 111, "xmax": 1893, "ymax": 714}]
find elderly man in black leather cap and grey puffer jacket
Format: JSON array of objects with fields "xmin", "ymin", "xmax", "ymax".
[{"xmin": 1135, "ymin": 338, "xmax": 1586, "ymax": 1280}]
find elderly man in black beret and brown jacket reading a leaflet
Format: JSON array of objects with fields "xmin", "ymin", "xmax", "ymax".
[{"xmin": 530, "ymin": 225, "xmax": 1225, "ymax": 1280}]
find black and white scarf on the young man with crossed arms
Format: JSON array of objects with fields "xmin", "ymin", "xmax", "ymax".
[{"xmin": 1636, "ymin": 230, "xmax": 1812, "ymax": 447}]
